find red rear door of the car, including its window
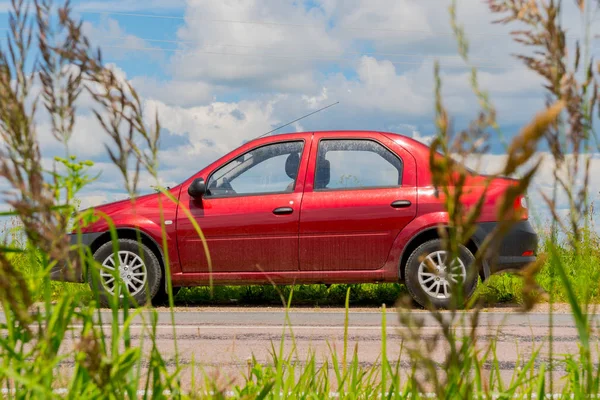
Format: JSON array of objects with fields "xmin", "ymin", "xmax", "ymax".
[{"xmin": 299, "ymin": 133, "xmax": 417, "ymax": 271}]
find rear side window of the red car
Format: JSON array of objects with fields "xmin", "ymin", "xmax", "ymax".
[{"xmin": 314, "ymin": 139, "xmax": 402, "ymax": 190}]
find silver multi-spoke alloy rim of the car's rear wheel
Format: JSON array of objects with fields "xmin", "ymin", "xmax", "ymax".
[{"xmin": 417, "ymin": 250, "xmax": 467, "ymax": 300}]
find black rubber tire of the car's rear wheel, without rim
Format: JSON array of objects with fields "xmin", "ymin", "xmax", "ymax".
[{"xmin": 404, "ymin": 239, "xmax": 479, "ymax": 308}]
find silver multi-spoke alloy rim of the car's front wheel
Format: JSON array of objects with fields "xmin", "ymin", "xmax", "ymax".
[{"xmin": 100, "ymin": 250, "xmax": 148, "ymax": 297}]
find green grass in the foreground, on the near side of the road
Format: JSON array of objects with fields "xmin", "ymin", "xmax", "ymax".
[{"xmin": 0, "ymin": 248, "xmax": 600, "ymax": 399}]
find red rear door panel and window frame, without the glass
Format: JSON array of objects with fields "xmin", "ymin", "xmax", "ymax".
[{"xmin": 300, "ymin": 132, "xmax": 417, "ymax": 271}]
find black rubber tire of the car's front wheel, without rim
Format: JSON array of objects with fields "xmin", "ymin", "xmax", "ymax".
[{"xmin": 87, "ymin": 239, "xmax": 163, "ymax": 307}]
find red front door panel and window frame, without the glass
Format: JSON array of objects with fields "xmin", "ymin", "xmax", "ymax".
[{"xmin": 177, "ymin": 135, "xmax": 311, "ymax": 273}]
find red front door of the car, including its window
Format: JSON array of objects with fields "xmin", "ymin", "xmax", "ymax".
[{"xmin": 177, "ymin": 139, "xmax": 308, "ymax": 273}]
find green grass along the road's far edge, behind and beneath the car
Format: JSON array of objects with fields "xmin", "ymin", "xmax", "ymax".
[{"xmin": 11, "ymin": 228, "xmax": 600, "ymax": 307}]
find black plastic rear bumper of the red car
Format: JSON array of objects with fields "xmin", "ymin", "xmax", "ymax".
[{"xmin": 474, "ymin": 221, "xmax": 539, "ymax": 278}]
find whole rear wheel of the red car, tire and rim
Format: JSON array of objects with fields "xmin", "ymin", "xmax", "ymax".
[{"xmin": 404, "ymin": 239, "xmax": 478, "ymax": 308}]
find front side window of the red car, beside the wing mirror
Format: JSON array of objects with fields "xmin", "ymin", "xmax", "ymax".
[{"xmin": 207, "ymin": 141, "xmax": 304, "ymax": 197}]
